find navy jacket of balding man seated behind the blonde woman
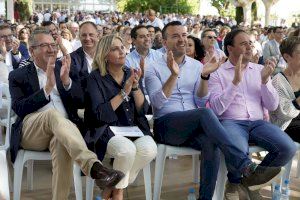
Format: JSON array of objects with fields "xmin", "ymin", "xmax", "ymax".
[{"xmin": 71, "ymin": 47, "xmax": 89, "ymax": 91}]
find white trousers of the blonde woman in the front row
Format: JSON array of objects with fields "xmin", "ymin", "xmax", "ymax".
[{"xmin": 106, "ymin": 136, "xmax": 157, "ymax": 189}]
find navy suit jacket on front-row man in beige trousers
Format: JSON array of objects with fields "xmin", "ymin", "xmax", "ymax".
[{"xmin": 9, "ymin": 61, "xmax": 84, "ymax": 162}]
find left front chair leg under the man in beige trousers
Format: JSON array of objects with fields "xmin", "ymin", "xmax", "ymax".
[{"xmin": 13, "ymin": 150, "xmax": 24, "ymax": 200}]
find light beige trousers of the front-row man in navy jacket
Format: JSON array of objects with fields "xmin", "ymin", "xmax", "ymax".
[{"xmin": 21, "ymin": 109, "xmax": 100, "ymax": 200}]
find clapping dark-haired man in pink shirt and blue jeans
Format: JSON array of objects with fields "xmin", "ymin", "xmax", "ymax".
[{"xmin": 209, "ymin": 29, "xmax": 296, "ymax": 200}]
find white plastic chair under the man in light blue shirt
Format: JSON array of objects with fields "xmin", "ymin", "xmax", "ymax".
[{"xmin": 153, "ymin": 144, "xmax": 201, "ymax": 200}]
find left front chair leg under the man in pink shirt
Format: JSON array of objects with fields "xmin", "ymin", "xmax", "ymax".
[{"xmin": 213, "ymin": 154, "xmax": 227, "ymax": 200}]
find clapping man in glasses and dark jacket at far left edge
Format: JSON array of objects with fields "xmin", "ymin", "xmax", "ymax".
[{"xmin": 0, "ymin": 24, "xmax": 29, "ymax": 71}]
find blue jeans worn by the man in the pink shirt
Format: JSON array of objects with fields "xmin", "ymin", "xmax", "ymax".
[{"xmin": 221, "ymin": 120, "xmax": 296, "ymax": 183}]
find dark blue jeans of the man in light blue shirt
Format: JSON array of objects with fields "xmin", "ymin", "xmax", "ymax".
[{"xmin": 154, "ymin": 108, "xmax": 251, "ymax": 200}]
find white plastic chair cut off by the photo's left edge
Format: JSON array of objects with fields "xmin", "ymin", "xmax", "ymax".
[{"xmin": 0, "ymin": 84, "xmax": 12, "ymax": 200}]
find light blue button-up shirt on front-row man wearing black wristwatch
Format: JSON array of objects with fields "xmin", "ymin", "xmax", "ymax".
[{"xmin": 145, "ymin": 54, "xmax": 209, "ymax": 119}]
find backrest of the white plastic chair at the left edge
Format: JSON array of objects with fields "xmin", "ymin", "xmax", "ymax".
[{"xmin": 0, "ymin": 83, "xmax": 12, "ymax": 150}]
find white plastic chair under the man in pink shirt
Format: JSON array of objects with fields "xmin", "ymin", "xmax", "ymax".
[{"xmin": 214, "ymin": 146, "xmax": 266, "ymax": 200}]
